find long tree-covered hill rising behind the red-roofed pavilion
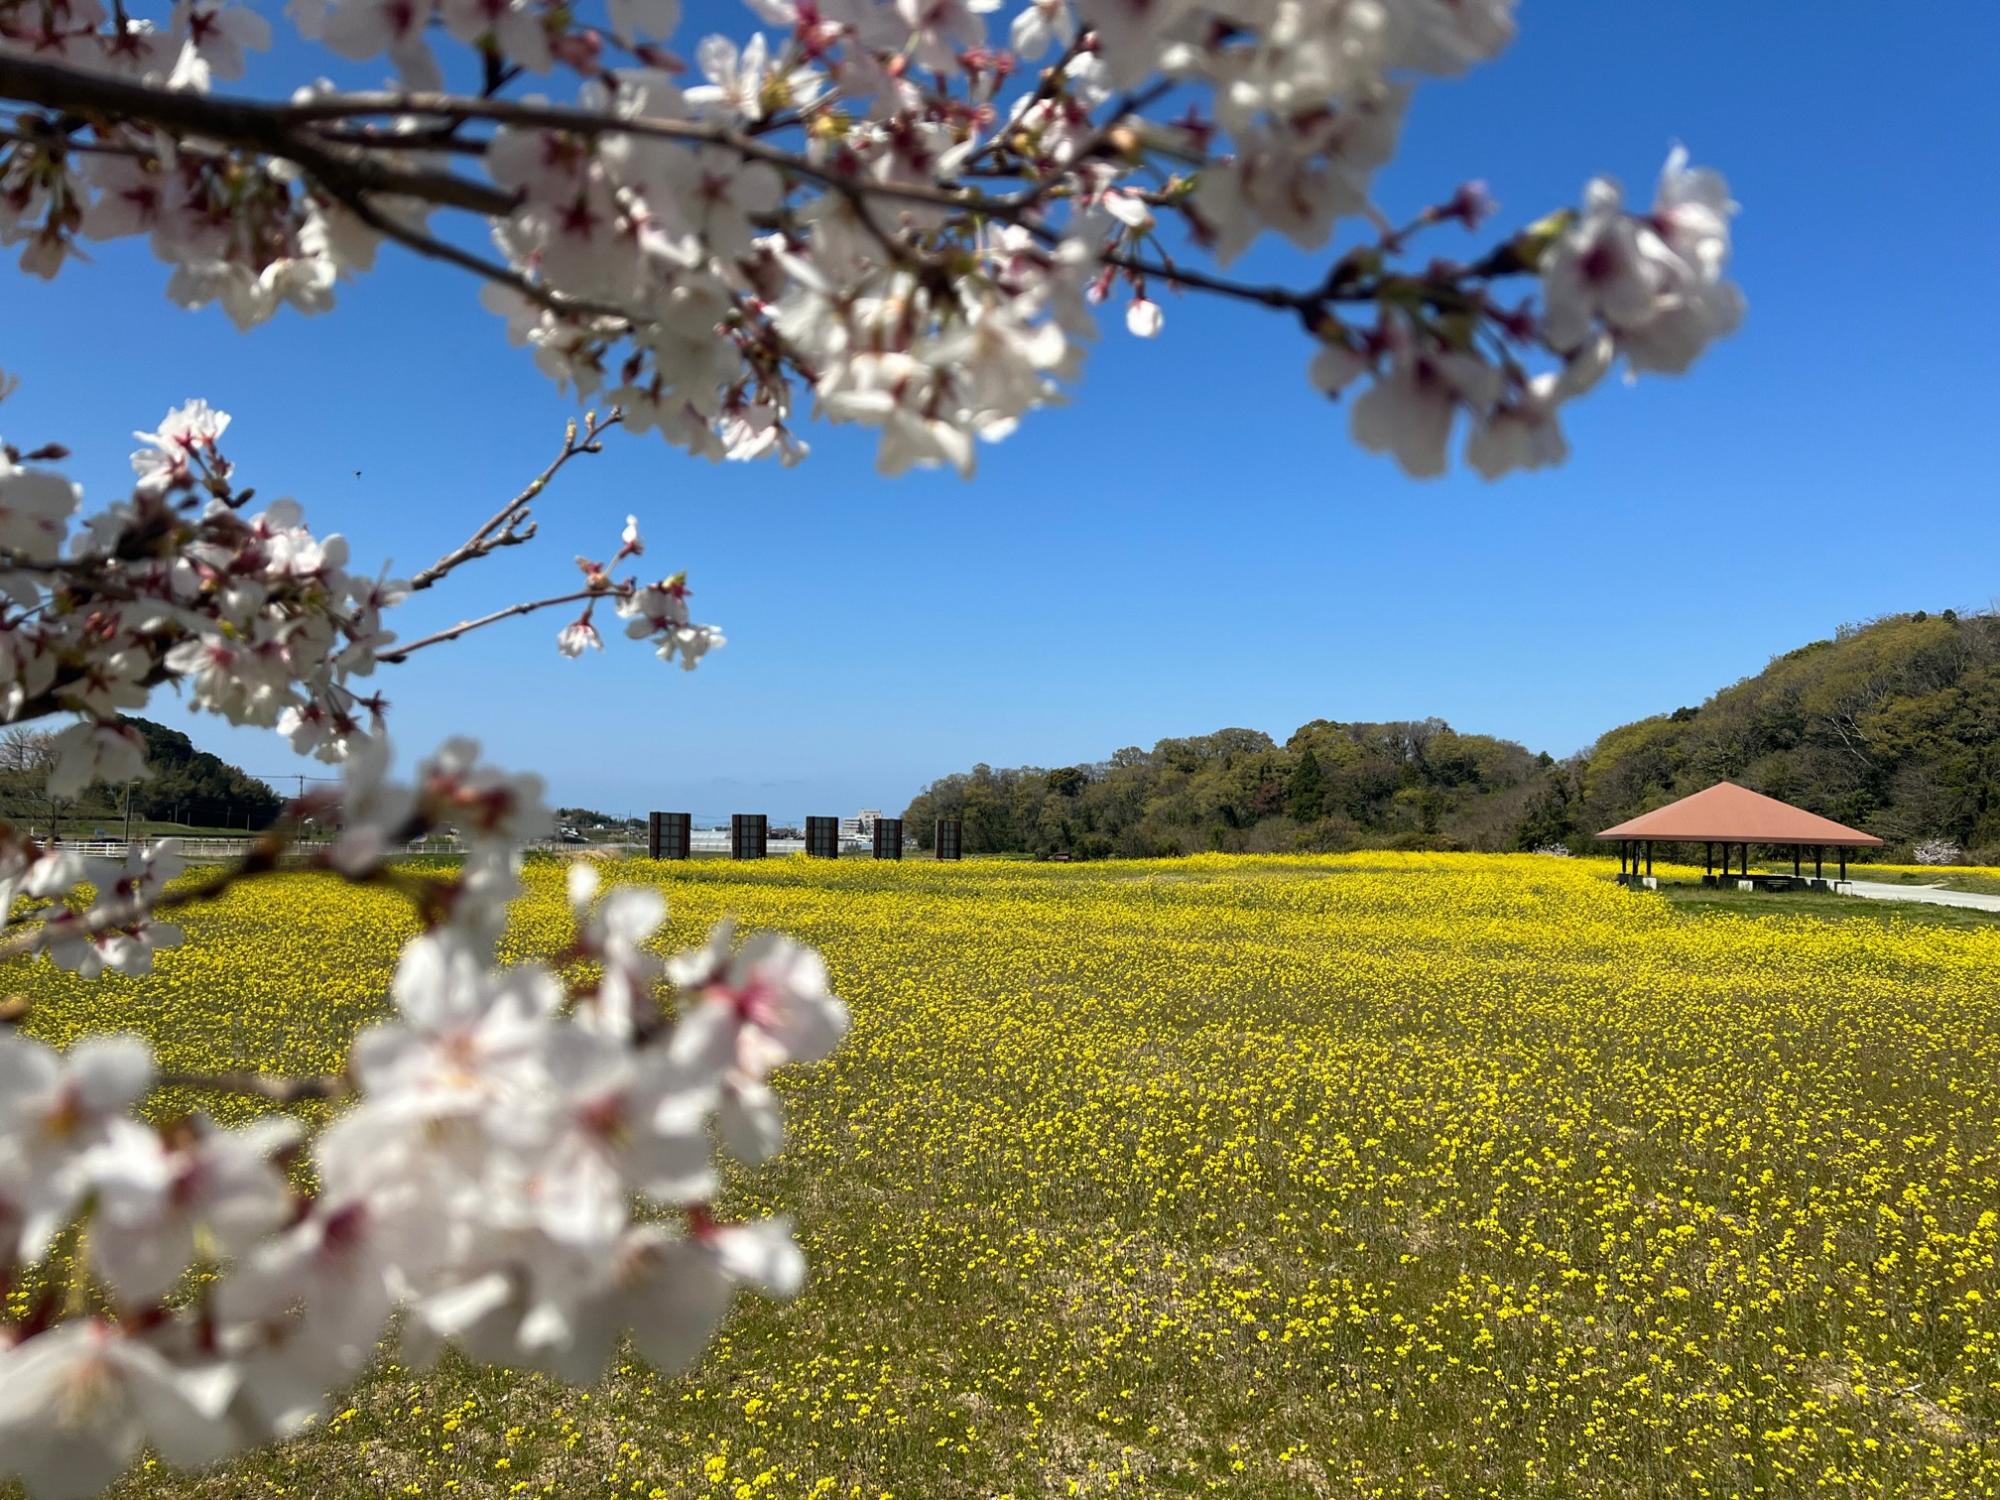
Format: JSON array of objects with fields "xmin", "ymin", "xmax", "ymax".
[{"xmin": 904, "ymin": 610, "xmax": 2000, "ymax": 858}]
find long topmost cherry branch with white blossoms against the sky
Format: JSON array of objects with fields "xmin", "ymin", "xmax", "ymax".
[{"xmin": 0, "ymin": 32, "xmax": 1742, "ymax": 488}]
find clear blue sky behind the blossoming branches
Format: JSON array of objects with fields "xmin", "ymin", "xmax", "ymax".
[{"xmin": 0, "ymin": 0, "xmax": 2000, "ymax": 818}]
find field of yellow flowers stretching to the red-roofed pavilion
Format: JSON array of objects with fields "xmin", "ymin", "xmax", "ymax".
[{"xmin": 0, "ymin": 854, "xmax": 2000, "ymax": 1500}]
